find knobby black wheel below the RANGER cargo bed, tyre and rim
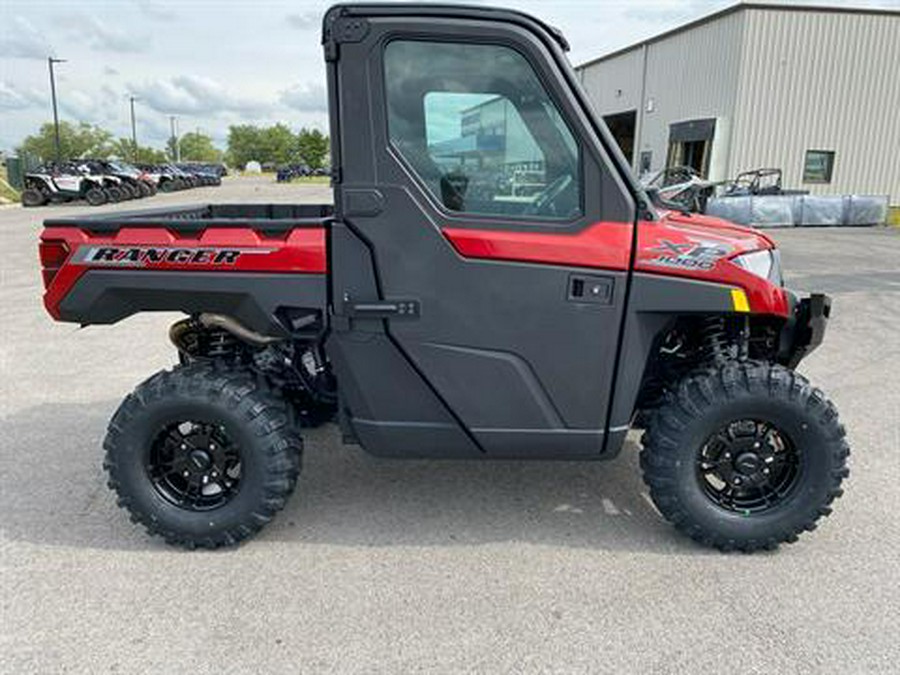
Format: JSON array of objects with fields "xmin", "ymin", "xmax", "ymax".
[{"xmin": 104, "ymin": 362, "xmax": 301, "ymax": 548}]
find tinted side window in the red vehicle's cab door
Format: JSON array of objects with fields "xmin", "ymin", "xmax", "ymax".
[{"xmin": 384, "ymin": 40, "xmax": 582, "ymax": 220}]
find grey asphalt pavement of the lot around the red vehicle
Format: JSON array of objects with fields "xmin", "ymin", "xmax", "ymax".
[{"xmin": 0, "ymin": 179, "xmax": 900, "ymax": 673}]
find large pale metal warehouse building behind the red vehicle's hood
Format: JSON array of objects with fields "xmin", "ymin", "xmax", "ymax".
[{"xmin": 578, "ymin": 2, "xmax": 900, "ymax": 204}]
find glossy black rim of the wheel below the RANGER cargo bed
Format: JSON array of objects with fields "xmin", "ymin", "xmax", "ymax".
[{"xmin": 146, "ymin": 420, "xmax": 241, "ymax": 511}]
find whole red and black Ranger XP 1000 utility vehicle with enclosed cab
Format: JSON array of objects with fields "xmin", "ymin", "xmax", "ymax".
[{"xmin": 40, "ymin": 4, "xmax": 849, "ymax": 551}]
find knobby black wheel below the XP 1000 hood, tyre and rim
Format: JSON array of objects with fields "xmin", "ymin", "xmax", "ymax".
[{"xmin": 641, "ymin": 362, "xmax": 850, "ymax": 552}]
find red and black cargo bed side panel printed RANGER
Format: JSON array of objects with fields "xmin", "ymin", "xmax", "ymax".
[{"xmin": 41, "ymin": 227, "xmax": 327, "ymax": 336}]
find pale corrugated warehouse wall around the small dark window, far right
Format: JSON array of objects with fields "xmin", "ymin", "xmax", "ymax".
[{"xmin": 729, "ymin": 9, "xmax": 900, "ymax": 199}]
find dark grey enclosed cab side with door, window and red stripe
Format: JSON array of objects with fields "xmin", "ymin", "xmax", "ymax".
[{"xmin": 326, "ymin": 7, "xmax": 634, "ymax": 457}]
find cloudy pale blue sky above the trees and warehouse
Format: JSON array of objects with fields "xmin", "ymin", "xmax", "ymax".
[{"xmin": 0, "ymin": 0, "xmax": 900, "ymax": 151}]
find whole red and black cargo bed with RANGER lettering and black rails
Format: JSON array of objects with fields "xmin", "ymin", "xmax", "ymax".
[{"xmin": 41, "ymin": 204, "xmax": 333, "ymax": 335}]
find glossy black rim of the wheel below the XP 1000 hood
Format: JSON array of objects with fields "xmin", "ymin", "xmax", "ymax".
[{"xmin": 697, "ymin": 419, "xmax": 801, "ymax": 515}]
